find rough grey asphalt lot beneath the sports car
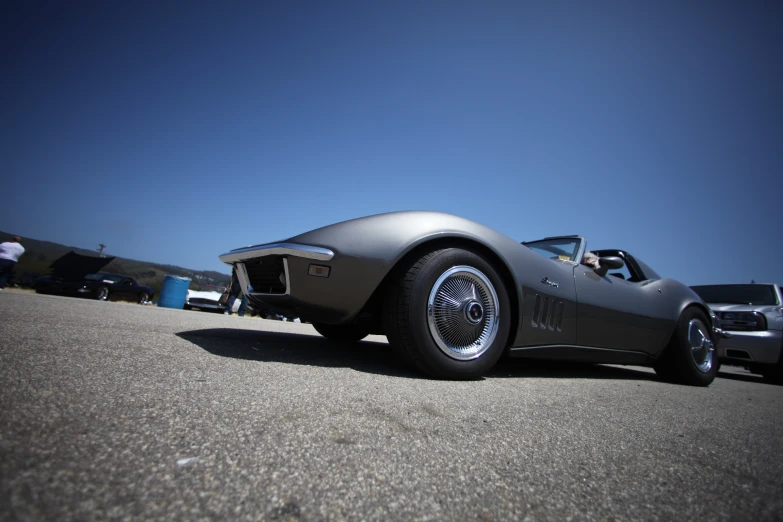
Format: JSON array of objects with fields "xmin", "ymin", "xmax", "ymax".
[{"xmin": 0, "ymin": 291, "xmax": 783, "ymax": 521}]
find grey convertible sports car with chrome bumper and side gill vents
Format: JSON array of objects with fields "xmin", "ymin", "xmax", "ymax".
[{"xmin": 220, "ymin": 211, "xmax": 721, "ymax": 386}]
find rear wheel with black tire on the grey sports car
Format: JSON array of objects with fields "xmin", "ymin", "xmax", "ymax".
[{"xmin": 654, "ymin": 307, "xmax": 719, "ymax": 386}]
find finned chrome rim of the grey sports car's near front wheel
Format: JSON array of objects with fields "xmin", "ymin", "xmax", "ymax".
[{"xmin": 427, "ymin": 266, "xmax": 500, "ymax": 361}]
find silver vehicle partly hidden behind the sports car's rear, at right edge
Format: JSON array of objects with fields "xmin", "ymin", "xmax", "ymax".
[{"xmin": 691, "ymin": 283, "xmax": 783, "ymax": 383}]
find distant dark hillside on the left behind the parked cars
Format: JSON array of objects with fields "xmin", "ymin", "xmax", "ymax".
[{"xmin": 0, "ymin": 232, "xmax": 231, "ymax": 295}]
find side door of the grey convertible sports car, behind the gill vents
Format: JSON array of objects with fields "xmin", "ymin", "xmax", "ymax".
[{"xmin": 574, "ymin": 265, "xmax": 671, "ymax": 354}]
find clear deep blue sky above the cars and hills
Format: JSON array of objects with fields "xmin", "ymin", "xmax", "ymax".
[{"xmin": 0, "ymin": 0, "xmax": 783, "ymax": 284}]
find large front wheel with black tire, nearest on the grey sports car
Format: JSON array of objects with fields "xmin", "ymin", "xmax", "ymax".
[{"xmin": 383, "ymin": 248, "xmax": 511, "ymax": 379}]
